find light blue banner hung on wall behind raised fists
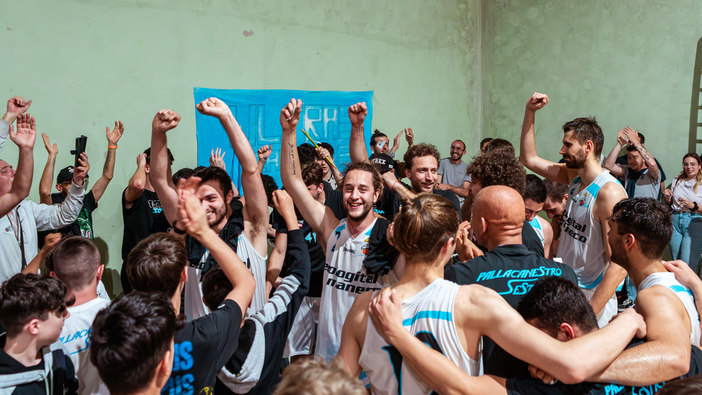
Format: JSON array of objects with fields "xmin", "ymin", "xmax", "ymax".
[{"xmin": 193, "ymin": 88, "xmax": 373, "ymax": 191}]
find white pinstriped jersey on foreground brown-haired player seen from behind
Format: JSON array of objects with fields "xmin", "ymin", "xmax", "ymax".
[{"xmin": 358, "ymin": 279, "xmax": 482, "ymax": 395}]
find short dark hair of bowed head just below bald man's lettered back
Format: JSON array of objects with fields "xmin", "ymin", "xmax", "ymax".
[{"xmin": 517, "ymin": 277, "xmax": 598, "ymax": 337}]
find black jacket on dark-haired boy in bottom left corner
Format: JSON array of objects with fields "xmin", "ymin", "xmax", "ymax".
[{"xmin": 0, "ymin": 335, "xmax": 78, "ymax": 395}]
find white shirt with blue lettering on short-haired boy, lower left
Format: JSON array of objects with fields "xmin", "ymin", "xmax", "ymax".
[{"xmin": 59, "ymin": 297, "xmax": 110, "ymax": 395}]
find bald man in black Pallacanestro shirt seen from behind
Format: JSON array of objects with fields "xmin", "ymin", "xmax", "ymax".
[{"xmin": 444, "ymin": 185, "xmax": 578, "ymax": 377}]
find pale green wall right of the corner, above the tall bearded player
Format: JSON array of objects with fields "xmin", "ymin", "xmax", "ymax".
[{"xmin": 482, "ymin": 0, "xmax": 702, "ymax": 180}]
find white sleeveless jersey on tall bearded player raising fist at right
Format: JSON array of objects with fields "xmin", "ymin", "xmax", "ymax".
[{"xmin": 557, "ymin": 170, "xmax": 624, "ymax": 289}]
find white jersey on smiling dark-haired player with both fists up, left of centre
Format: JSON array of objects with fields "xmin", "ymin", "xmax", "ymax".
[{"xmin": 183, "ymin": 232, "xmax": 268, "ymax": 321}]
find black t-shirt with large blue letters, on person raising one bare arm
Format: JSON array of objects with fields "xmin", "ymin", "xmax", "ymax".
[{"xmin": 161, "ymin": 300, "xmax": 242, "ymax": 395}]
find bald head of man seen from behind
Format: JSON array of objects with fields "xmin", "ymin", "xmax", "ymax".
[{"xmin": 471, "ymin": 185, "xmax": 524, "ymax": 250}]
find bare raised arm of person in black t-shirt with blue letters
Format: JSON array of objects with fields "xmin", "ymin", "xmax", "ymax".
[{"xmin": 179, "ymin": 178, "xmax": 256, "ymax": 312}]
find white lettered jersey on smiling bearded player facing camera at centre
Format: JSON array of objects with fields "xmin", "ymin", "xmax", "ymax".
[{"xmin": 315, "ymin": 219, "xmax": 396, "ymax": 361}]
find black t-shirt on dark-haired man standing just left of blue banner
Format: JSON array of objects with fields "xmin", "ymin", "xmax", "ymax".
[{"xmin": 122, "ymin": 188, "xmax": 168, "ymax": 261}]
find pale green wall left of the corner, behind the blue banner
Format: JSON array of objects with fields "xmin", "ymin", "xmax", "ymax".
[{"xmin": 0, "ymin": 0, "xmax": 480, "ymax": 294}]
